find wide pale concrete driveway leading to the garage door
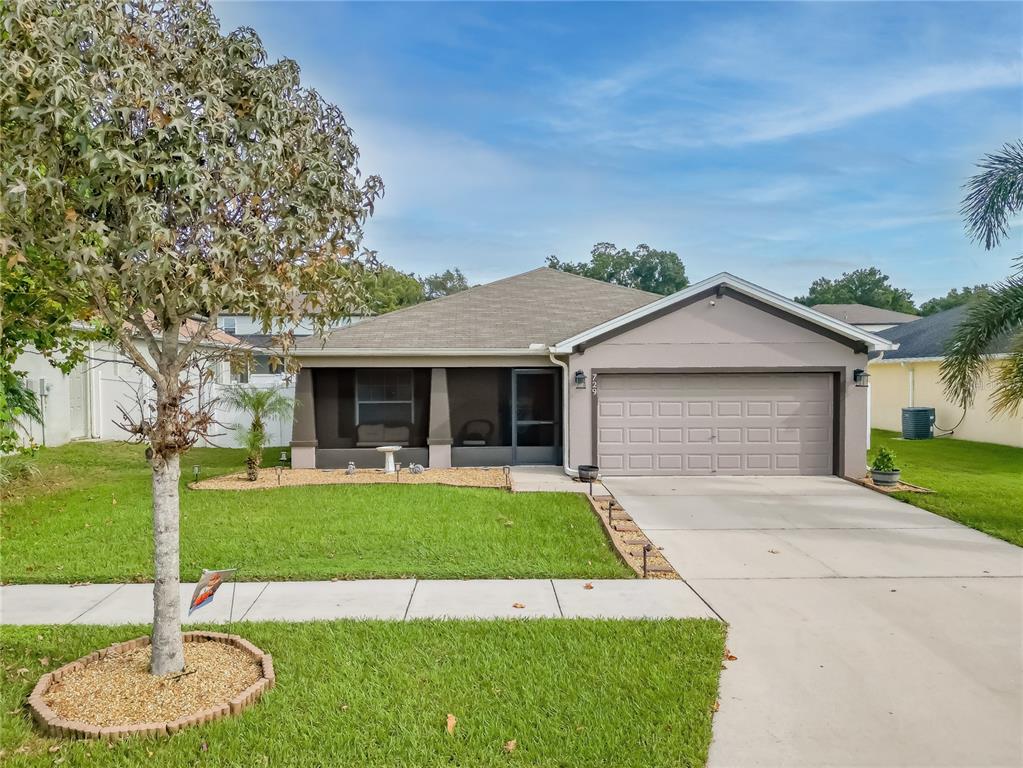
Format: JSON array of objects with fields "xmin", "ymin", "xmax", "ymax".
[{"xmin": 606, "ymin": 478, "xmax": 1023, "ymax": 768}]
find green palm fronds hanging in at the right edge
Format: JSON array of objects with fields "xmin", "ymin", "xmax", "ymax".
[{"xmin": 941, "ymin": 140, "xmax": 1023, "ymax": 415}]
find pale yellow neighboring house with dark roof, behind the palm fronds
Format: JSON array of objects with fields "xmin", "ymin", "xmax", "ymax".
[{"xmin": 870, "ymin": 307, "xmax": 1023, "ymax": 446}]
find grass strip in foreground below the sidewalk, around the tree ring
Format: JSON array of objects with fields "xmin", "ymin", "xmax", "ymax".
[{"xmin": 0, "ymin": 619, "xmax": 724, "ymax": 768}]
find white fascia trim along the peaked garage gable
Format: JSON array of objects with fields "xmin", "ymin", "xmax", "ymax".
[{"xmin": 553, "ymin": 272, "xmax": 898, "ymax": 354}]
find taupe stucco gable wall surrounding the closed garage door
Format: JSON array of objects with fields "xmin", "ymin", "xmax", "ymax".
[{"xmin": 569, "ymin": 296, "xmax": 868, "ymax": 478}]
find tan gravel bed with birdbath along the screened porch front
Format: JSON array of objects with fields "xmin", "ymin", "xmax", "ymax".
[{"xmin": 188, "ymin": 467, "xmax": 507, "ymax": 491}]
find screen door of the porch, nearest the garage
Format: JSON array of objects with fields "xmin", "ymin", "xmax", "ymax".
[{"xmin": 512, "ymin": 368, "xmax": 561, "ymax": 464}]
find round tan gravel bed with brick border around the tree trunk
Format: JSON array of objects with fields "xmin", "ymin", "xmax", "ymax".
[{"xmin": 29, "ymin": 632, "xmax": 275, "ymax": 739}]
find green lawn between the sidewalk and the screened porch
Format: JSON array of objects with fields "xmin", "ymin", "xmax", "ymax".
[{"xmin": 2, "ymin": 443, "xmax": 632, "ymax": 583}]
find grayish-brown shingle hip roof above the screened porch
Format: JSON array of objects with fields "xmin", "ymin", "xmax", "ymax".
[{"xmin": 296, "ymin": 267, "xmax": 661, "ymax": 354}]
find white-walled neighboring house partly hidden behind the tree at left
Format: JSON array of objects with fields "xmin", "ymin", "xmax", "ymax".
[{"xmin": 14, "ymin": 321, "xmax": 261, "ymax": 447}]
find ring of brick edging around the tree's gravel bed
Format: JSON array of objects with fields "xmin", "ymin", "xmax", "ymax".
[{"xmin": 29, "ymin": 632, "xmax": 277, "ymax": 741}]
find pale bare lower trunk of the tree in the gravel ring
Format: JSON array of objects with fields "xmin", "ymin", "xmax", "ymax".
[{"xmin": 149, "ymin": 453, "xmax": 185, "ymax": 675}]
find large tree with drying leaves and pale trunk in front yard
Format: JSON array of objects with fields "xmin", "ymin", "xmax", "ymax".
[{"xmin": 0, "ymin": 0, "xmax": 383, "ymax": 675}]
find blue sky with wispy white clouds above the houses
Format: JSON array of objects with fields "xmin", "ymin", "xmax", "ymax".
[{"xmin": 216, "ymin": 2, "xmax": 1023, "ymax": 301}]
